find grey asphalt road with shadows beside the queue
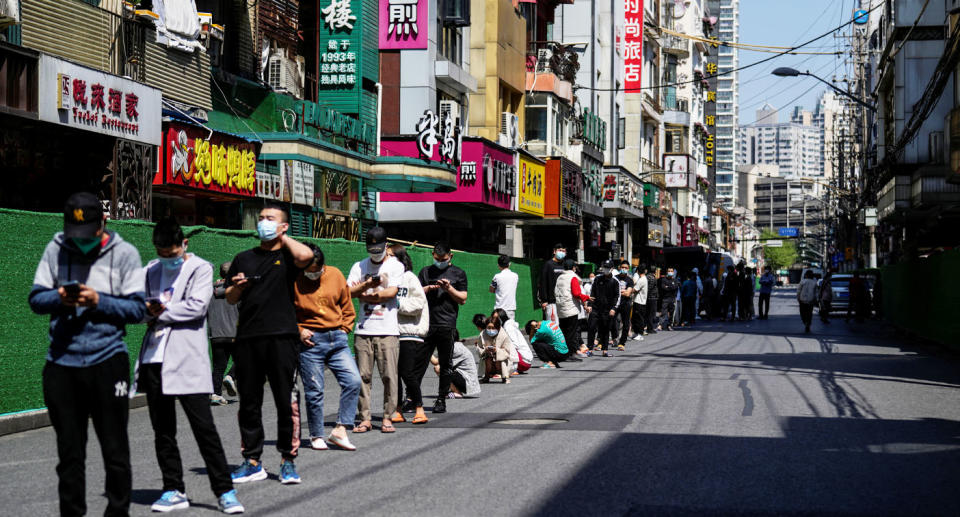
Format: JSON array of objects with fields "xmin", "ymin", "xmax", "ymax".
[{"xmin": 0, "ymin": 291, "xmax": 960, "ymax": 516}]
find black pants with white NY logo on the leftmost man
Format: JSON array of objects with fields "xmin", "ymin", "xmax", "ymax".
[{"xmin": 43, "ymin": 352, "xmax": 132, "ymax": 515}]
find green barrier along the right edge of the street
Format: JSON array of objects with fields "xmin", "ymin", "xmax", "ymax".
[{"xmin": 880, "ymin": 250, "xmax": 960, "ymax": 349}]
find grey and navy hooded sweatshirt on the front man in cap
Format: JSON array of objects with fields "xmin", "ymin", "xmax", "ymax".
[{"xmin": 28, "ymin": 230, "xmax": 147, "ymax": 367}]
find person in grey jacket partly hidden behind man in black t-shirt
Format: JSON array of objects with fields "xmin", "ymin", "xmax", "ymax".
[{"xmin": 207, "ymin": 262, "xmax": 239, "ymax": 406}]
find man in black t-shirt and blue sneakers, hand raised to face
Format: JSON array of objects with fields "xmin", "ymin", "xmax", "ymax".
[{"xmin": 226, "ymin": 204, "xmax": 313, "ymax": 485}]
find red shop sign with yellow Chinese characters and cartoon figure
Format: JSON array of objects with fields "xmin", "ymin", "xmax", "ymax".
[{"xmin": 154, "ymin": 123, "xmax": 257, "ymax": 196}]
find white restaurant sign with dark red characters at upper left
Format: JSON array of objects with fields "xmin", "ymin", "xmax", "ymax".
[{"xmin": 38, "ymin": 54, "xmax": 161, "ymax": 145}]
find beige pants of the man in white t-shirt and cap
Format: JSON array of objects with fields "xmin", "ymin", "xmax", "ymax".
[{"xmin": 353, "ymin": 336, "xmax": 400, "ymax": 422}]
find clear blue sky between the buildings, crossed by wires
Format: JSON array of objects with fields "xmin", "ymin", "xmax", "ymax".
[{"xmin": 739, "ymin": 0, "xmax": 859, "ymax": 125}]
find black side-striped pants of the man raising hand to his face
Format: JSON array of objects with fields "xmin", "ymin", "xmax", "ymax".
[{"xmin": 234, "ymin": 335, "xmax": 300, "ymax": 460}]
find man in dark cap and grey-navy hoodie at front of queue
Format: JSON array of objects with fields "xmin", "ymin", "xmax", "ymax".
[{"xmin": 29, "ymin": 192, "xmax": 147, "ymax": 515}]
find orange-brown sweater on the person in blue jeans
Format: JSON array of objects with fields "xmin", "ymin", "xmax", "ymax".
[{"xmin": 293, "ymin": 266, "xmax": 356, "ymax": 333}]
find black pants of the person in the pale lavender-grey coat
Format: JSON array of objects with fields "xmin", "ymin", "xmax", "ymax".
[{"xmin": 138, "ymin": 363, "xmax": 233, "ymax": 497}]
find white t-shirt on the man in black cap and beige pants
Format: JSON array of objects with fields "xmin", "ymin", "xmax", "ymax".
[{"xmin": 347, "ymin": 257, "xmax": 404, "ymax": 336}]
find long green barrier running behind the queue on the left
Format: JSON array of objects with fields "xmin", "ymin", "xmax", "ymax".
[{"xmin": 0, "ymin": 209, "xmax": 541, "ymax": 414}]
